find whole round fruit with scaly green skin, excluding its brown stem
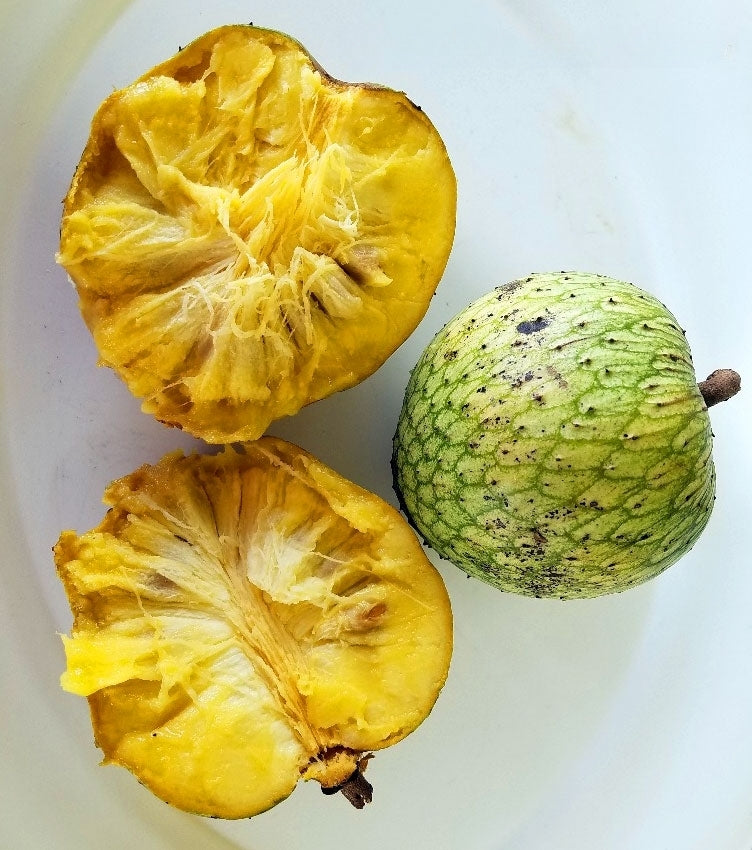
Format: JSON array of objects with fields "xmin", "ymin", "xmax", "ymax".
[{"xmin": 392, "ymin": 272, "xmax": 715, "ymax": 599}]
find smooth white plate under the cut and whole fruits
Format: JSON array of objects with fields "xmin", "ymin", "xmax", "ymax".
[{"xmin": 0, "ymin": 0, "xmax": 752, "ymax": 850}]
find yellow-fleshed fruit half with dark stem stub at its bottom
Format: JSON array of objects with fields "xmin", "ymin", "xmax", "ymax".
[{"xmin": 55, "ymin": 437, "xmax": 452, "ymax": 818}]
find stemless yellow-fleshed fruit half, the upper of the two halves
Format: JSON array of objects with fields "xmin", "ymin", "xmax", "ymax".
[{"xmin": 58, "ymin": 26, "xmax": 456, "ymax": 443}]
